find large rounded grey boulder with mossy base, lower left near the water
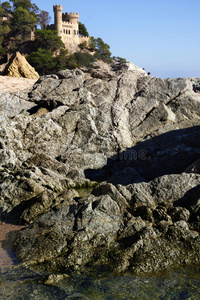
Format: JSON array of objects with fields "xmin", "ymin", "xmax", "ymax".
[{"xmin": 15, "ymin": 195, "xmax": 122, "ymax": 268}]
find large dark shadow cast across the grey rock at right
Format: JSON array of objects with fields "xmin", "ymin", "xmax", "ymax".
[{"xmin": 85, "ymin": 126, "xmax": 200, "ymax": 185}]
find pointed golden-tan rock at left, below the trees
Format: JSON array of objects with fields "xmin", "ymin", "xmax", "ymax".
[{"xmin": 4, "ymin": 52, "xmax": 40, "ymax": 79}]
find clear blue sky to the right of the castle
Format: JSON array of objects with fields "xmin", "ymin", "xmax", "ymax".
[{"xmin": 32, "ymin": 0, "xmax": 200, "ymax": 78}]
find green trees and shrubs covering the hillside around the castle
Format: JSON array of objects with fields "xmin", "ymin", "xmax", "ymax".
[{"xmin": 0, "ymin": 0, "xmax": 123, "ymax": 75}]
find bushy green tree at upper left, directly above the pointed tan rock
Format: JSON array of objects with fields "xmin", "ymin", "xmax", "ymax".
[{"xmin": 11, "ymin": 7, "xmax": 37, "ymax": 35}]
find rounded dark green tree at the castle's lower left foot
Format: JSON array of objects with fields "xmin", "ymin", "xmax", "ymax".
[{"xmin": 35, "ymin": 29, "xmax": 64, "ymax": 51}]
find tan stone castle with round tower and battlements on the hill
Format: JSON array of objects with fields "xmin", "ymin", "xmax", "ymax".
[{"xmin": 48, "ymin": 5, "xmax": 90, "ymax": 53}]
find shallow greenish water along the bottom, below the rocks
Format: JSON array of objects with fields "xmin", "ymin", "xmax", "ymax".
[{"xmin": 0, "ymin": 267, "xmax": 200, "ymax": 300}]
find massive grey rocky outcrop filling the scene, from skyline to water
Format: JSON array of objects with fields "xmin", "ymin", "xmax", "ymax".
[{"xmin": 0, "ymin": 62, "xmax": 200, "ymax": 274}]
